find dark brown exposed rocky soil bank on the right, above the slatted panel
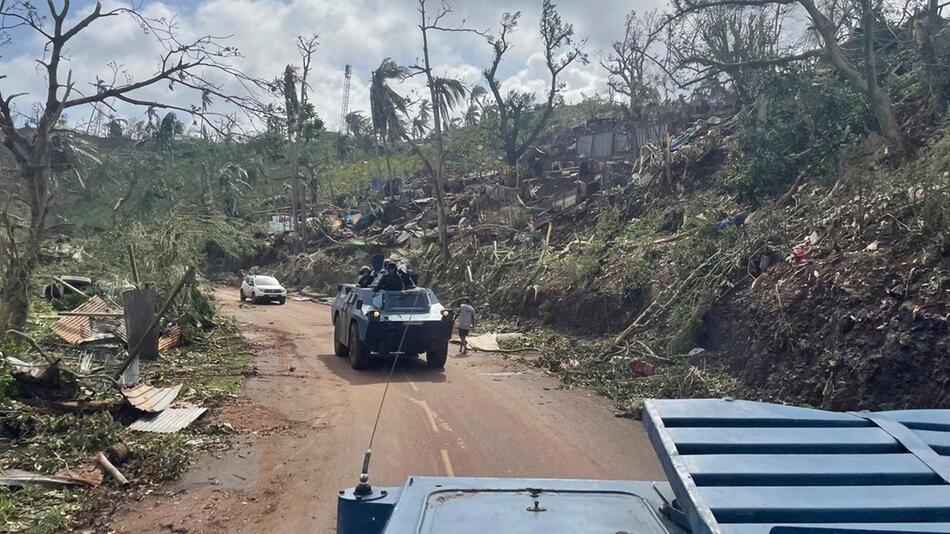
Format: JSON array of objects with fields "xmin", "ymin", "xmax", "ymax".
[{"xmin": 705, "ymin": 243, "xmax": 950, "ymax": 410}]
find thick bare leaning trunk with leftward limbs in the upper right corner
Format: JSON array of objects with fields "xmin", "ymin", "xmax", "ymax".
[{"xmin": 670, "ymin": 0, "xmax": 907, "ymax": 156}]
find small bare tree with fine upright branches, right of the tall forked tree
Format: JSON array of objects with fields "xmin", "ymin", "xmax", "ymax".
[{"xmin": 600, "ymin": 11, "xmax": 663, "ymax": 122}]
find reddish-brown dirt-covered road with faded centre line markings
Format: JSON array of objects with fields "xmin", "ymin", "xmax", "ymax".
[{"xmin": 112, "ymin": 289, "xmax": 663, "ymax": 533}]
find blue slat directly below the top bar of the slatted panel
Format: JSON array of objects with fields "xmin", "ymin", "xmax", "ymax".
[{"xmin": 668, "ymin": 427, "xmax": 904, "ymax": 454}]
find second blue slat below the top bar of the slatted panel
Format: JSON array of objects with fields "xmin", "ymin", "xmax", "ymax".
[{"xmin": 681, "ymin": 454, "xmax": 941, "ymax": 486}]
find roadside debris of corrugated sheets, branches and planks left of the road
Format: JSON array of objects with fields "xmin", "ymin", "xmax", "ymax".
[{"xmin": 0, "ymin": 258, "xmax": 244, "ymax": 529}]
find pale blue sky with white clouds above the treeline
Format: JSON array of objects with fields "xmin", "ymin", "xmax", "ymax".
[{"xmin": 0, "ymin": 0, "xmax": 662, "ymax": 133}]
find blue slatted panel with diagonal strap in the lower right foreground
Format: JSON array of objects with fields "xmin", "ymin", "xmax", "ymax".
[{"xmin": 643, "ymin": 399, "xmax": 950, "ymax": 534}]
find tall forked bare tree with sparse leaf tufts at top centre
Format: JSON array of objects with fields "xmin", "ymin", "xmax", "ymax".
[{"xmin": 483, "ymin": 0, "xmax": 587, "ymax": 182}]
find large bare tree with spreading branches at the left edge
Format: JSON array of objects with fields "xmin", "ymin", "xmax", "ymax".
[{"xmin": 0, "ymin": 0, "xmax": 259, "ymax": 332}]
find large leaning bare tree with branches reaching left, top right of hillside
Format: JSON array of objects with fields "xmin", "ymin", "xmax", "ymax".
[{"xmin": 671, "ymin": 0, "xmax": 907, "ymax": 157}]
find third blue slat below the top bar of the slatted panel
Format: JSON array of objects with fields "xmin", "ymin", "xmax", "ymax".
[{"xmin": 700, "ymin": 484, "xmax": 950, "ymax": 524}]
